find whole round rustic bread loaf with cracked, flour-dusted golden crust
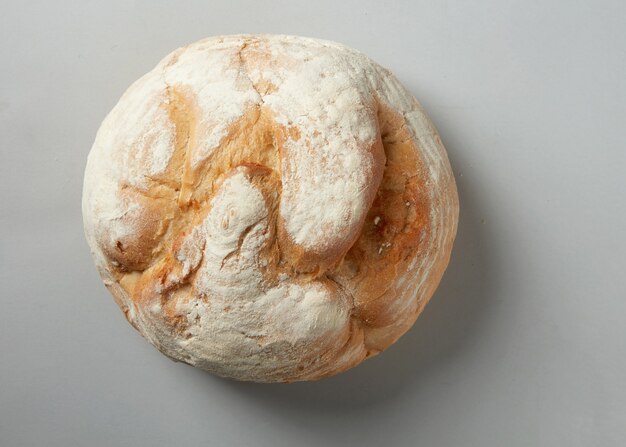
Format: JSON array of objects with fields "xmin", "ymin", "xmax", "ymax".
[{"xmin": 83, "ymin": 35, "xmax": 458, "ymax": 382}]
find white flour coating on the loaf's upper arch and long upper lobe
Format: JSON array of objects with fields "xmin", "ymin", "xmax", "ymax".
[{"xmin": 87, "ymin": 37, "xmax": 378, "ymax": 258}]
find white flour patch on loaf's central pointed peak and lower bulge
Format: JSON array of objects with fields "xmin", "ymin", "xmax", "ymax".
[{"xmin": 154, "ymin": 168, "xmax": 350, "ymax": 375}]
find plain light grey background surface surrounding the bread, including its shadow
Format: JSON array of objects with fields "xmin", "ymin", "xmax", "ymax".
[{"xmin": 0, "ymin": 0, "xmax": 626, "ymax": 447}]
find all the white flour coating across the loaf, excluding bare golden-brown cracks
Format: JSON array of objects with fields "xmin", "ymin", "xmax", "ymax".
[{"xmin": 83, "ymin": 36, "xmax": 456, "ymax": 380}]
